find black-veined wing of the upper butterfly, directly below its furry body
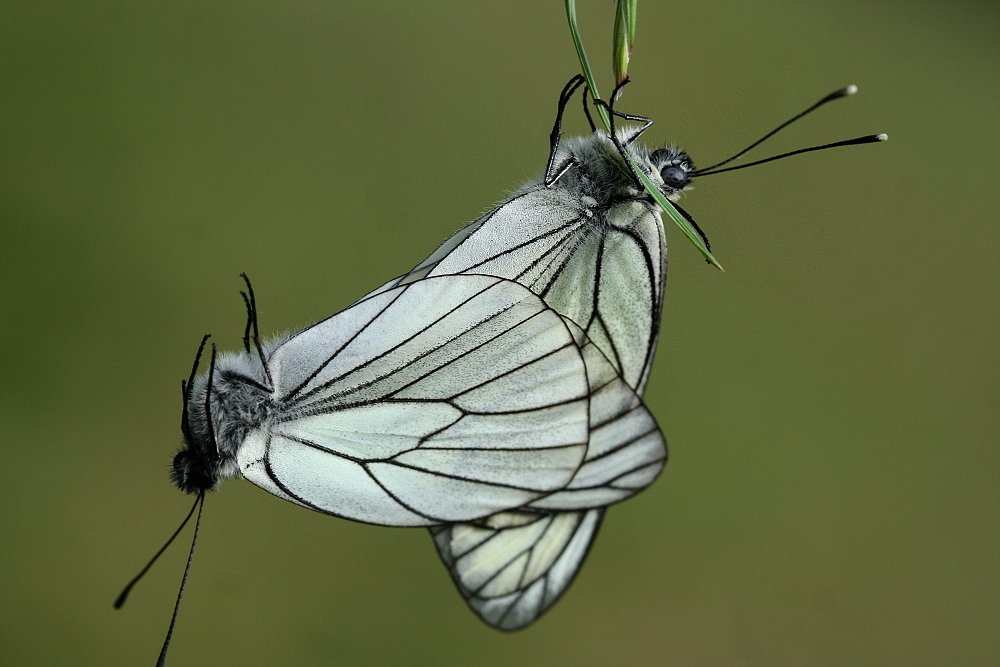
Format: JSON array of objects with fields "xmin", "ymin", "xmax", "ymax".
[{"xmin": 374, "ymin": 185, "xmax": 666, "ymax": 395}]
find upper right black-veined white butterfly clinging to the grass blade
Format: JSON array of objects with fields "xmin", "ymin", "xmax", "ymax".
[{"xmin": 376, "ymin": 77, "xmax": 693, "ymax": 630}]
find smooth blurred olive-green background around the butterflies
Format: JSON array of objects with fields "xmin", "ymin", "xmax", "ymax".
[{"xmin": 0, "ymin": 0, "xmax": 1000, "ymax": 667}]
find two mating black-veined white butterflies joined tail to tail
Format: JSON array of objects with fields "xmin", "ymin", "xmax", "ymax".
[{"xmin": 116, "ymin": 76, "xmax": 884, "ymax": 660}]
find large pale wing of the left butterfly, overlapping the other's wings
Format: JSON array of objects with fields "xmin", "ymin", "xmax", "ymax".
[{"xmin": 237, "ymin": 276, "xmax": 589, "ymax": 526}]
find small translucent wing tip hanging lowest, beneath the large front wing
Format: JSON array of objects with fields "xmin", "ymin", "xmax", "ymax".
[{"xmin": 430, "ymin": 509, "xmax": 604, "ymax": 631}]
